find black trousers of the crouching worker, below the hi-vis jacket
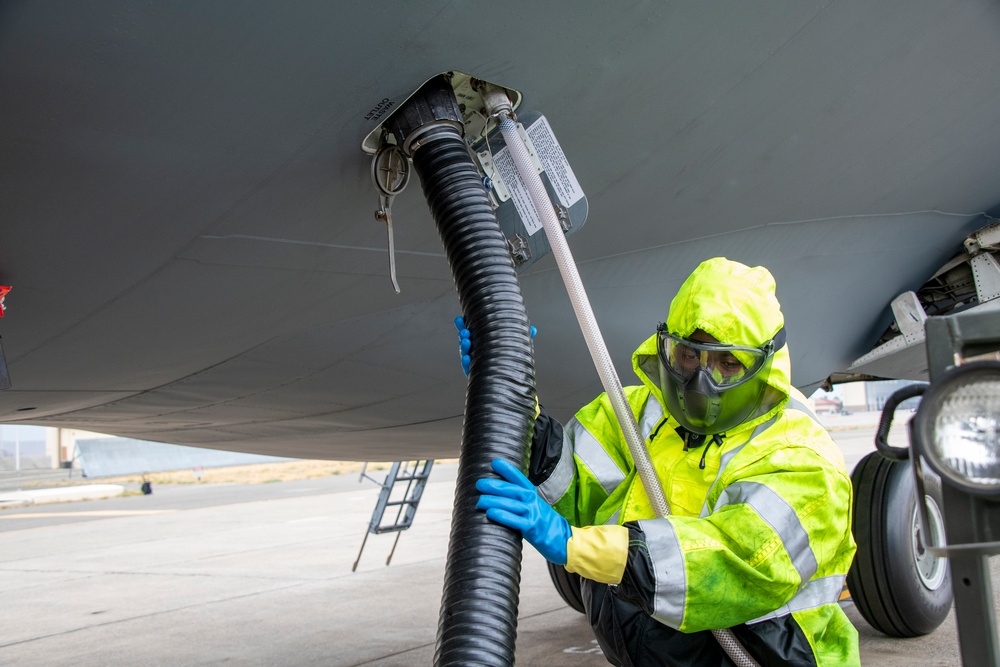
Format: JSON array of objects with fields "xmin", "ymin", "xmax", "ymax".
[{"xmin": 582, "ymin": 579, "xmax": 816, "ymax": 667}]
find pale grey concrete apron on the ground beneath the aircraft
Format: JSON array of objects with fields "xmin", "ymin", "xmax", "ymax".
[{"xmin": 0, "ymin": 420, "xmax": 1000, "ymax": 667}]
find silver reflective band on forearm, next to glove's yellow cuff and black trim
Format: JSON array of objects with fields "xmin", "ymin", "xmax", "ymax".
[{"xmin": 638, "ymin": 519, "xmax": 687, "ymax": 628}]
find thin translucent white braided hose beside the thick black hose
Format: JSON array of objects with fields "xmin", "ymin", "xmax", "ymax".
[{"xmin": 496, "ymin": 116, "xmax": 758, "ymax": 667}]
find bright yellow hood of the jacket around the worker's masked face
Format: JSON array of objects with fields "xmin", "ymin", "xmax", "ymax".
[{"xmin": 632, "ymin": 257, "xmax": 791, "ymax": 431}]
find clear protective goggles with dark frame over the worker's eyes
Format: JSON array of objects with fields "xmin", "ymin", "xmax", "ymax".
[{"xmin": 656, "ymin": 324, "xmax": 785, "ymax": 390}]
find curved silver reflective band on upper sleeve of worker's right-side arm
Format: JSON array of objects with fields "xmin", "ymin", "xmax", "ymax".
[{"xmin": 715, "ymin": 482, "xmax": 818, "ymax": 581}]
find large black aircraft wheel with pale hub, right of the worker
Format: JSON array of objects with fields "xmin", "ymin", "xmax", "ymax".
[{"xmin": 847, "ymin": 452, "xmax": 952, "ymax": 637}]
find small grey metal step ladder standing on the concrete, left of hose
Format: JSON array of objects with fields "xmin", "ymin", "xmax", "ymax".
[{"xmin": 351, "ymin": 459, "xmax": 434, "ymax": 572}]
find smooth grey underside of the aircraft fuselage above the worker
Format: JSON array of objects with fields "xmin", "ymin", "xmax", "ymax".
[{"xmin": 0, "ymin": 0, "xmax": 1000, "ymax": 460}]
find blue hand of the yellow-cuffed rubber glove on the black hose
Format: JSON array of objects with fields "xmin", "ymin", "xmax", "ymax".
[{"xmin": 476, "ymin": 459, "xmax": 573, "ymax": 565}]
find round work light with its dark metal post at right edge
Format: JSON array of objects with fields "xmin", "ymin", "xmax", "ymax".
[{"xmin": 910, "ymin": 309, "xmax": 1000, "ymax": 665}]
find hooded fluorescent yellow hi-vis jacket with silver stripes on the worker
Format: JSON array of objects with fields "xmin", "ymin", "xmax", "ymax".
[{"xmin": 531, "ymin": 258, "xmax": 860, "ymax": 665}]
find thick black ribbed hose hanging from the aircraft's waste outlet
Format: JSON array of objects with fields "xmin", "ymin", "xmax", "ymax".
[{"xmin": 413, "ymin": 127, "xmax": 535, "ymax": 666}]
